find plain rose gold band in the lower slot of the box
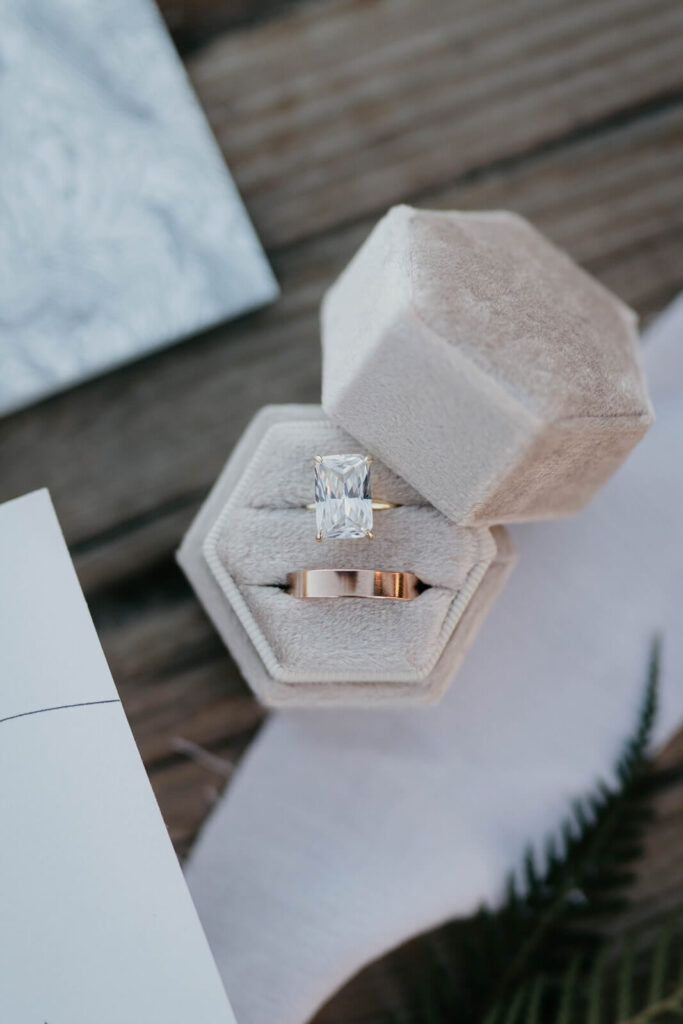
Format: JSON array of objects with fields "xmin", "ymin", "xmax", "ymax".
[{"xmin": 287, "ymin": 569, "xmax": 423, "ymax": 601}]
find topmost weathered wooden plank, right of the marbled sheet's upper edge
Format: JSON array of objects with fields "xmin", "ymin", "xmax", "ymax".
[{"xmin": 189, "ymin": 0, "xmax": 683, "ymax": 246}]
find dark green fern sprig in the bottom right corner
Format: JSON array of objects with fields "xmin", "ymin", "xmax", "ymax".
[{"xmin": 393, "ymin": 641, "xmax": 683, "ymax": 1024}]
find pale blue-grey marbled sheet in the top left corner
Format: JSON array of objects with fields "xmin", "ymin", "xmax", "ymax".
[{"xmin": 0, "ymin": 0, "xmax": 276, "ymax": 413}]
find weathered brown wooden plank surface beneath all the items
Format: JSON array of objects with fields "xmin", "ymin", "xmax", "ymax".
[{"xmin": 0, "ymin": 0, "xmax": 683, "ymax": 1024}]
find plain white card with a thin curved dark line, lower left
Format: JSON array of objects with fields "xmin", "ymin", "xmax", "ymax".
[{"xmin": 0, "ymin": 490, "xmax": 239, "ymax": 1024}]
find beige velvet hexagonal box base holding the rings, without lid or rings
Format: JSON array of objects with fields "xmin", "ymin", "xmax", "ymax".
[{"xmin": 178, "ymin": 406, "xmax": 515, "ymax": 706}]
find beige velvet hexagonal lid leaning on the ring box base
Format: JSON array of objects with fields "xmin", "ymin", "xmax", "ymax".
[{"xmin": 322, "ymin": 206, "xmax": 652, "ymax": 525}]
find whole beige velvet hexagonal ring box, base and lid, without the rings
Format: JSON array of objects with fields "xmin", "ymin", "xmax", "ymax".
[{"xmin": 178, "ymin": 206, "xmax": 652, "ymax": 707}]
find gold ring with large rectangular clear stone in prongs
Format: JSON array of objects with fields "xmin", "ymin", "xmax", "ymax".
[{"xmin": 306, "ymin": 455, "xmax": 396, "ymax": 541}]
